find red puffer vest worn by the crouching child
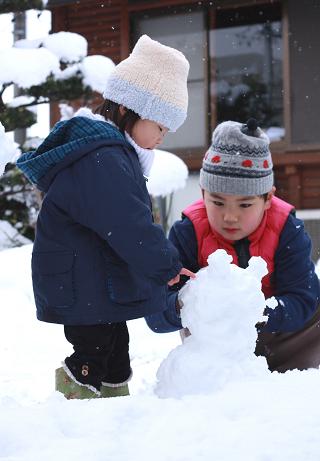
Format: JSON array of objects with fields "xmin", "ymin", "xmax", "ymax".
[{"xmin": 183, "ymin": 197, "xmax": 293, "ymax": 298}]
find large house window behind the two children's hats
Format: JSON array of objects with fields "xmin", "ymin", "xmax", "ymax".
[{"xmin": 131, "ymin": 2, "xmax": 284, "ymax": 166}]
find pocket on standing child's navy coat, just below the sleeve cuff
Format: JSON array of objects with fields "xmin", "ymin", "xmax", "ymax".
[{"xmin": 107, "ymin": 263, "xmax": 151, "ymax": 305}]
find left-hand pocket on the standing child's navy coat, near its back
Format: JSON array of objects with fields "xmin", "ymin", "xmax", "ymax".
[{"xmin": 31, "ymin": 252, "xmax": 75, "ymax": 307}]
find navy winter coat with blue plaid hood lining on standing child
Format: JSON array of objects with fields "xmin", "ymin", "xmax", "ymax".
[{"xmin": 17, "ymin": 117, "xmax": 182, "ymax": 325}]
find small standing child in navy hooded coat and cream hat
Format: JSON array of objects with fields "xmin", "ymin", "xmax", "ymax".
[{"xmin": 17, "ymin": 36, "xmax": 189, "ymax": 398}]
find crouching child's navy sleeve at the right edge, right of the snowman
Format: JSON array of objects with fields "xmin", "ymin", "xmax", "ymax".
[{"xmin": 265, "ymin": 215, "xmax": 320, "ymax": 332}]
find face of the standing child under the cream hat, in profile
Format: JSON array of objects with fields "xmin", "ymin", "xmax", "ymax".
[{"xmin": 130, "ymin": 119, "xmax": 168, "ymax": 149}]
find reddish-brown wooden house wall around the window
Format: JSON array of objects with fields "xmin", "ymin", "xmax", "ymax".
[{"xmin": 51, "ymin": 0, "xmax": 320, "ymax": 209}]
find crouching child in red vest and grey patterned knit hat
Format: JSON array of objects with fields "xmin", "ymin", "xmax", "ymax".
[{"xmin": 146, "ymin": 119, "xmax": 320, "ymax": 372}]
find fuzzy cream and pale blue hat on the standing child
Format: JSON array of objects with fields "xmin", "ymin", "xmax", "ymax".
[{"xmin": 103, "ymin": 35, "xmax": 189, "ymax": 131}]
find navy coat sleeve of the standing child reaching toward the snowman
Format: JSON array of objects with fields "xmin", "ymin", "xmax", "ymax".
[{"xmin": 49, "ymin": 147, "xmax": 182, "ymax": 284}]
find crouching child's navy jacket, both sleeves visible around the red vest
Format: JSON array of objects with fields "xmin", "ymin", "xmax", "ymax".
[{"xmin": 146, "ymin": 210, "xmax": 320, "ymax": 333}]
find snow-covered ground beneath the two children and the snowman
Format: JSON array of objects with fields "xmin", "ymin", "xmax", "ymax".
[{"xmin": 0, "ymin": 245, "xmax": 320, "ymax": 461}]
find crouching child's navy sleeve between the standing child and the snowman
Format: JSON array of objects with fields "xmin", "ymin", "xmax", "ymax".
[{"xmin": 146, "ymin": 217, "xmax": 200, "ymax": 333}]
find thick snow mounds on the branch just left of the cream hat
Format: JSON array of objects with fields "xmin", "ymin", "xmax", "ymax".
[{"xmin": 0, "ymin": 32, "xmax": 115, "ymax": 93}]
